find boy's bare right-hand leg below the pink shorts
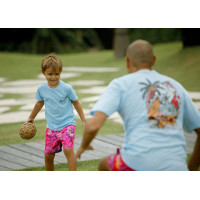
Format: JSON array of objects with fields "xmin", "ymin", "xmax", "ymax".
[{"xmin": 63, "ymin": 148, "xmax": 76, "ymax": 171}]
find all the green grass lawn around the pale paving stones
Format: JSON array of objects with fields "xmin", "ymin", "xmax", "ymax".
[{"xmin": 0, "ymin": 42, "xmax": 200, "ymax": 170}]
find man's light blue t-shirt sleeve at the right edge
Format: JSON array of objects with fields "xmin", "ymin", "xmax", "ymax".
[{"xmin": 183, "ymin": 91, "xmax": 200, "ymax": 132}]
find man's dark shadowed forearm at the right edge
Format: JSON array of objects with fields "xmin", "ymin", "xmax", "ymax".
[{"xmin": 188, "ymin": 128, "xmax": 200, "ymax": 171}]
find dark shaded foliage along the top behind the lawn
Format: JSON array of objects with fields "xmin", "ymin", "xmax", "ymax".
[{"xmin": 0, "ymin": 28, "xmax": 181, "ymax": 54}]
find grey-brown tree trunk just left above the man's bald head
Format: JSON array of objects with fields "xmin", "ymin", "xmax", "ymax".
[{"xmin": 114, "ymin": 28, "xmax": 130, "ymax": 58}]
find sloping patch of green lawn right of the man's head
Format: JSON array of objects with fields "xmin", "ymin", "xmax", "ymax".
[{"xmin": 154, "ymin": 43, "xmax": 200, "ymax": 91}]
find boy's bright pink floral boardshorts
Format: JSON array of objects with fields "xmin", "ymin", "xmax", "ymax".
[{"xmin": 44, "ymin": 125, "xmax": 76, "ymax": 154}]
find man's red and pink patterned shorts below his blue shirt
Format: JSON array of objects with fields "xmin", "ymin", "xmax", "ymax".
[{"xmin": 108, "ymin": 148, "xmax": 136, "ymax": 171}]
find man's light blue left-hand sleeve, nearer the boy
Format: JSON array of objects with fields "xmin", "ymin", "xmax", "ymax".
[{"xmin": 91, "ymin": 80, "xmax": 121, "ymax": 117}]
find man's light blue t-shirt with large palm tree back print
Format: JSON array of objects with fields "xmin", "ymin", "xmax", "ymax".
[{"xmin": 91, "ymin": 70, "xmax": 200, "ymax": 171}]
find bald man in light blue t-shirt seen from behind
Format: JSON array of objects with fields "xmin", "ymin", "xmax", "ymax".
[{"xmin": 76, "ymin": 40, "xmax": 200, "ymax": 171}]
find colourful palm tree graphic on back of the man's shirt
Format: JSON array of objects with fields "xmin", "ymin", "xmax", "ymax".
[{"xmin": 139, "ymin": 79, "xmax": 180, "ymax": 128}]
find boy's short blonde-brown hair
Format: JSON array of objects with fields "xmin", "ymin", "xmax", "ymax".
[{"xmin": 41, "ymin": 54, "xmax": 62, "ymax": 72}]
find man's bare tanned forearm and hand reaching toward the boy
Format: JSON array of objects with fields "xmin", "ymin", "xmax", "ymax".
[{"xmin": 76, "ymin": 111, "xmax": 108, "ymax": 158}]
